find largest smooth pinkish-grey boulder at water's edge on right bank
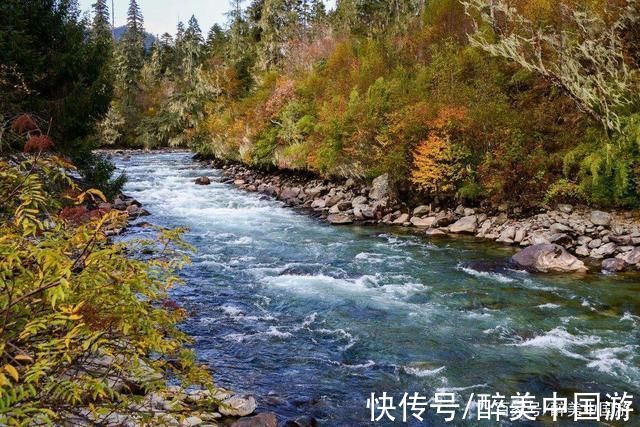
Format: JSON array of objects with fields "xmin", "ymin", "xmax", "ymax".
[{"xmin": 511, "ymin": 244, "xmax": 588, "ymax": 273}]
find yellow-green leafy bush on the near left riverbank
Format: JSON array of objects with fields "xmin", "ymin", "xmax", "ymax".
[{"xmin": 0, "ymin": 155, "xmax": 211, "ymax": 425}]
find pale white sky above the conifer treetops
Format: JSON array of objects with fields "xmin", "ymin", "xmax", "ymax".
[{"xmin": 79, "ymin": 0, "xmax": 335, "ymax": 35}]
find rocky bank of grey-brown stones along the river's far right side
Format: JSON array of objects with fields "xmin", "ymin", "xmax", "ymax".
[{"xmin": 197, "ymin": 162, "xmax": 640, "ymax": 272}]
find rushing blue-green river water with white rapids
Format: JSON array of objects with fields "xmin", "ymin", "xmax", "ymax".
[{"xmin": 115, "ymin": 153, "xmax": 640, "ymax": 426}]
